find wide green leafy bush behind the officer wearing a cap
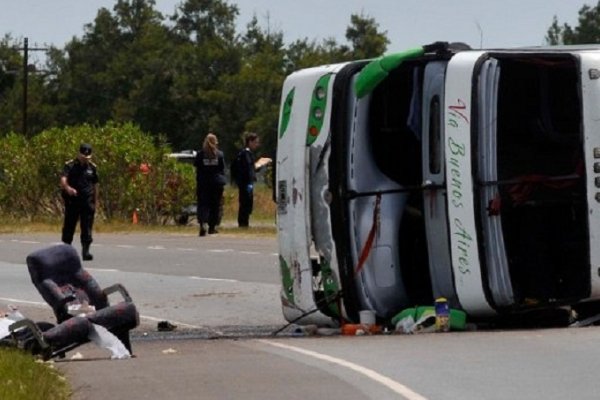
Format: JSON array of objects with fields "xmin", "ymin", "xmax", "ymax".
[{"xmin": 0, "ymin": 124, "xmax": 195, "ymax": 223}]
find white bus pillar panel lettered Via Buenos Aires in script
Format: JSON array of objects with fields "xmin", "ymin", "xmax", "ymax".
[{"xmin": 444, "ymin": 52, "xmax": 495, "ymax": 316}]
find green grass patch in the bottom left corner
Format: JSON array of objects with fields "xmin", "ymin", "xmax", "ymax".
[{"xmin": 0, "ymin": 348, "xmax": 72, "ymax": 400}]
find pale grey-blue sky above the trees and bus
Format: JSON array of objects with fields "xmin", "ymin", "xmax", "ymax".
[{"xmin": 0, "ymin": 0, "xmax": 597, "ymax": 63}]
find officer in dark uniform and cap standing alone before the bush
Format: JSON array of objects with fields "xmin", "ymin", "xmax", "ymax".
[{"xmin": 60, "ymin": 143, "xmax": 98, "ymax": 261}]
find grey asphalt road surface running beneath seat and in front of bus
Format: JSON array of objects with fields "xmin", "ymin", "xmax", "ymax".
[{"xmin": 0, "ymin": 234, "xmax": 600, "ymax": 400}]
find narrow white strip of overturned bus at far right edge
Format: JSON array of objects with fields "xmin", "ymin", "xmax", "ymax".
[{"xmin": 581, "ymin": 53, "xmax": 600, "ymax": 299}]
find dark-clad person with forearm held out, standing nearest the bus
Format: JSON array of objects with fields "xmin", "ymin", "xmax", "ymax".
[{"xmin": 235, "ymin": 132, "xmax": 271, "ymax": 228}]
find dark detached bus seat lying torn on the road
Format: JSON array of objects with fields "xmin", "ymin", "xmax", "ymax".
[{"xmin": 10, "ymin": 244, "xmax": 139, "ymax": 358}]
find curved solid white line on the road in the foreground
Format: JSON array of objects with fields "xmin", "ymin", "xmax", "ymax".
[{"xmin": 258, "ymin": 339, "xmax": 427, "ymax": 400}]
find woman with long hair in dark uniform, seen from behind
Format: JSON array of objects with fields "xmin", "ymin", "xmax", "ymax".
[{"xmin": 194, "ymin": 133, "xmax": 226, "ymax": 236}]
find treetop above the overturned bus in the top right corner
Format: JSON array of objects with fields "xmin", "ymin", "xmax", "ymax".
[{"xmin": 546, "ymin": 1, "xmax": 600, "ymax": 45}]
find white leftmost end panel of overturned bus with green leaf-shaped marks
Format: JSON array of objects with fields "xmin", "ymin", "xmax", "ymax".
[{"xmin": 276, "ymin": 67, "xmax": 342, "ymax": 325}]
